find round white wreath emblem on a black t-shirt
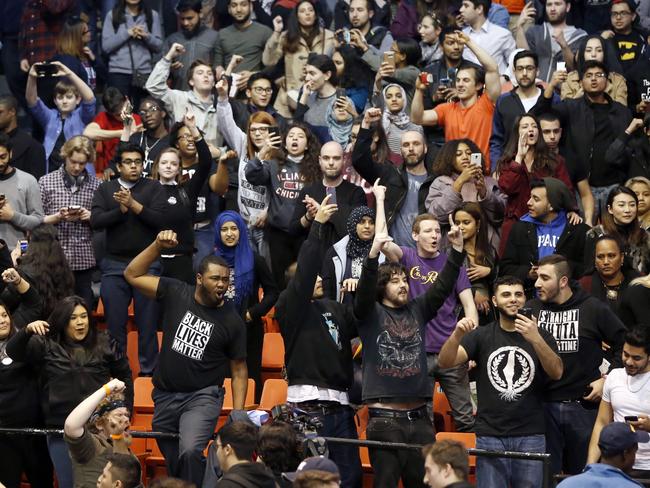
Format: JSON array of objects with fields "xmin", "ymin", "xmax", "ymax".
[{"xmin": 487, "ymin": 346, "xmax": 535, "ymax": 402}]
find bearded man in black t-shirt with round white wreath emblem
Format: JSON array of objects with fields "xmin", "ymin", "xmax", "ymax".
[{"xmin": 438, "ymin": 276, "xmax": 563, "ymax": 488}]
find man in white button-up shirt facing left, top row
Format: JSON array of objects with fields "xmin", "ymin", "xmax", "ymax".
[{"xmin": 460, "ymin": 0, "xmax": 516, "ymax": 75}]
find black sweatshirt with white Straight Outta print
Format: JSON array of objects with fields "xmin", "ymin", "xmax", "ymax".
[{"xmin": 526, "ymin": 283, "xmax": 625, "ymax": 402}]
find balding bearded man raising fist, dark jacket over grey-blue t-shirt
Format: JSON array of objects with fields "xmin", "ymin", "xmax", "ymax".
[{"xmin": 352, "ymin": 108, "xmax": 434, "ymax": 247}]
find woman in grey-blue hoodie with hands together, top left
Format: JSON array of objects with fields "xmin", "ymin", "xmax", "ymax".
[{"xmin": 102, "ymin": 0, "xmax": 163, "ymax": 107}]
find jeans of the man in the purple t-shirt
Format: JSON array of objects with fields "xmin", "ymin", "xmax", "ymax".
[{"xmin": 427, "ymin": 353, "xmax": 474, "ymax": 432}]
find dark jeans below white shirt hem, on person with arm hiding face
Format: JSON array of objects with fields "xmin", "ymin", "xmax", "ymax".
[{"xmin": 296, "ymin": 403, "xmax": 363, "ymax": 488}]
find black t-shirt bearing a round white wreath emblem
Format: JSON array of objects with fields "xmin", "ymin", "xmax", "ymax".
[{"xmin": 461, "ymin": 322, "xmax": 558, "ymax": 437}]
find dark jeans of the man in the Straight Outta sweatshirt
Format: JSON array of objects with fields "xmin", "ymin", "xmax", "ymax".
[{"xmin": 544, "ymin": 402, "xmax": 598, "ymax": 474}]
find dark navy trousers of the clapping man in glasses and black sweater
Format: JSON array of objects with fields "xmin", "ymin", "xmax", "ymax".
[{"xmin": 99, "ymin": 258, "xmax": 160, "ymax": 375}]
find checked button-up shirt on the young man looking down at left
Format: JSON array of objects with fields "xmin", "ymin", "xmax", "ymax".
[{"xmin": 38, "ymin": 166, "xmax": 100, "ymax": 271}]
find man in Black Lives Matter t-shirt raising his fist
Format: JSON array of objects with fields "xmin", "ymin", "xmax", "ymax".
[{"xmin": 124, "ymin": 230, "xmax": 248, "ymax": 486}]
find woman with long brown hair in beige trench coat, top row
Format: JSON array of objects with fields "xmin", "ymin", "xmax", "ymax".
[{"xmin": 262, "ymin": 0, "xmax": 334, "ymax": 117}]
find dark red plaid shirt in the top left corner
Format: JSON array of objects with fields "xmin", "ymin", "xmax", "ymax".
[{"xmin": 19, "ymin": 0, "xmax": 76, "ymax": 65}]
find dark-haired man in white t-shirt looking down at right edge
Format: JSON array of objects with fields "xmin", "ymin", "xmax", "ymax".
[{"xmin": 587, "ymin": 327, "xmax": 650, "ymax": 479}]
